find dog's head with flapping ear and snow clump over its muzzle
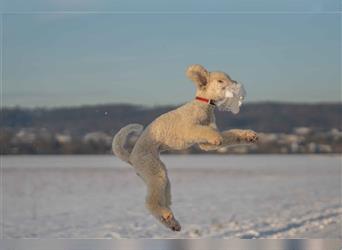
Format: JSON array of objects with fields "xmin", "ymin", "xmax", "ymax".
[{"xmin": 186, "ymin": 64, "xmax": 246, "ymax": 114}]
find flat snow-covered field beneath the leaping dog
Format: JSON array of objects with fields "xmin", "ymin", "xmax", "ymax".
[{"xmin": 1, "ymin": 155, "xmax": 342, "ymax": 238}]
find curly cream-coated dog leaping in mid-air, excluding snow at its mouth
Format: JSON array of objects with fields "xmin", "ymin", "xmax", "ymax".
[{"xmin": 113, "ymin": 64, "xmax": 257, "ymax": 231}]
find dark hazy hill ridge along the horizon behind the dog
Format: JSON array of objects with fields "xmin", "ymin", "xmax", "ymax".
[{"xmin": 0, "ymin": 102, "xmax": 342, "ymax": 136}]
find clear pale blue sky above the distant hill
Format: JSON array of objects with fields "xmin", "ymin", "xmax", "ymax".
[{"xmin": 2, "ymin": 0, "xmax": 341, "ymax": 107}]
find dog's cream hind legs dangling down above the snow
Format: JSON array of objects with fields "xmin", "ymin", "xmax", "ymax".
[{"xmin": 131, "ymin": 154, "xmax": 181, "ymax": 231}]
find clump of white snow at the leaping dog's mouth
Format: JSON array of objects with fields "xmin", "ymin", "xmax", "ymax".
[{"xmin": 215, "ymin": 83, "xmax": 246, "ymax": 114}]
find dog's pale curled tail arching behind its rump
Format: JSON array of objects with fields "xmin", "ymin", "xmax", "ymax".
[{"xmin": 112, "ymin": 124, "xmax": 144, "ymax": 163}]
